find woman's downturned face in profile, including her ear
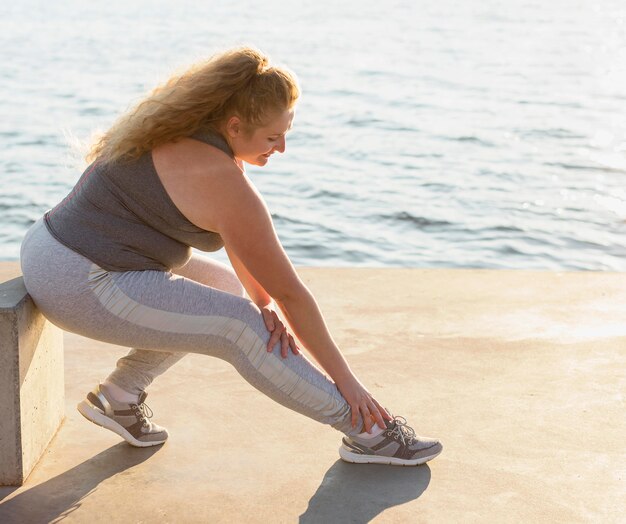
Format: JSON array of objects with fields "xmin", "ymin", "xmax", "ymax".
[{"xmin": 226, "ymin": 109, "xmax": 294, "ymax": 166}]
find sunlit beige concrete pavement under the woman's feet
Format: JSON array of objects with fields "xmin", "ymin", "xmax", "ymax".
[{"xmin": 0, "ymin": 263, "xmax": 626, "ymax": 524}]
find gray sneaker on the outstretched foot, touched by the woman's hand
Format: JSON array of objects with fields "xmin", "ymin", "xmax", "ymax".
[{"xmin": 339, "ymin": 417, "xmax": 443, "ymax": 466}]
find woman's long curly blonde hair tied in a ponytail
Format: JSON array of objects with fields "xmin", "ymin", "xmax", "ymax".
[{"xmin": 86, "ymin": 47, "xmax": 300, "ymax": 162}]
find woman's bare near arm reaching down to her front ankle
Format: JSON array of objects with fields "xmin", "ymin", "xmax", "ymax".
[{"xmin": 201, "ymin": 174, "xmax": 391, "ymax": 431}]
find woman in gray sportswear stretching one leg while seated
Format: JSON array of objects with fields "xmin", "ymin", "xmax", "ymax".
[{"xmin": 21, "ymin": 48, "xmax": 442, "ymax": 465}]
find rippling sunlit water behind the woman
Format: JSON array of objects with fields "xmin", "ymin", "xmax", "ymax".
[{"xmin": 0, "ymin": 0, "xmax": 626, "ymax": 271}]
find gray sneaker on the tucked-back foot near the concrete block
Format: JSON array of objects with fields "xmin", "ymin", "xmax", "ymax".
[{"xmin": 77, "ymin": 384, "xmax": 168, "ymax": 448}]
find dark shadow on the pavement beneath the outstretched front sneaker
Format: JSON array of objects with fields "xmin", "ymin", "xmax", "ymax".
[{"xmin": 300, "ymin": 460, "xmax": 430, "ymax": 524}]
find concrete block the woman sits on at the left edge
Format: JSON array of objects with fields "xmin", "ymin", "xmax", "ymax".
[{"xmin": 0, "ymin": 277, "xmax": 65, "ymax": 486}]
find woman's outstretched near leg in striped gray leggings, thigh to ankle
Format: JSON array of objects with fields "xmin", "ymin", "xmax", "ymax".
[{"xmin": 88, "ymin": 264, "xmax": 351, "ymax": 433}]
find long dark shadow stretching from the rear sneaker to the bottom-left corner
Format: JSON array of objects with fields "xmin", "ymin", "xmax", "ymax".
[{"xmin": 0, "ymin": 442, "xmax": 161, "ymax": 524}]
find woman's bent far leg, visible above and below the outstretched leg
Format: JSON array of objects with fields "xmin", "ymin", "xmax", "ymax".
[{"xmin": 104, "ymin": 253, "xmax": 245, "ymax": 398}]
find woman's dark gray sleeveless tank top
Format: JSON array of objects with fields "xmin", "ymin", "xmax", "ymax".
[{"xmin": 44, "ymin": 132, "xmax": 234, "ymax": 271}]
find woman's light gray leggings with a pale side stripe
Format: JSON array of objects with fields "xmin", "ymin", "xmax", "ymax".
[{"xmin": 21, "ymin": 220, "xmax": 362, "ymax": 435}]
